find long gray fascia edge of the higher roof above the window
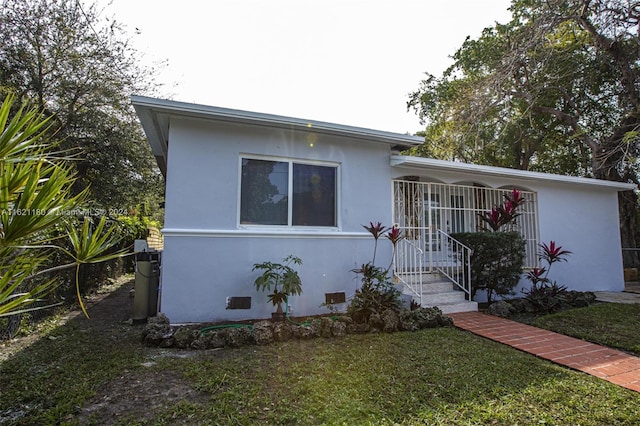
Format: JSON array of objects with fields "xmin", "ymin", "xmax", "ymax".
[{"xmin": 131, "ymin": 95, "xmax": 424, "ymax": 146}]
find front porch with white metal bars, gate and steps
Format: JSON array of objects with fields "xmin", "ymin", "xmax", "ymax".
[{"xmin": 393, "ymin": 178, "xmax": 539, "ymax": 313}]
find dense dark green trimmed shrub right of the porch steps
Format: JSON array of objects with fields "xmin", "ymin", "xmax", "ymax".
[{"xmin": 453, "ymin": 232, "xmax": 525, "ymax": 303}]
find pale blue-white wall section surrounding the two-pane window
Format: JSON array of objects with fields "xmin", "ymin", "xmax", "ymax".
[{"xmin": 161, "ymin": 119, "xmax": 391, "ymax": 323}]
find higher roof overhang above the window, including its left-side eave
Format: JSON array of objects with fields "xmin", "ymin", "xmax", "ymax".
[{"xmin": 131, "ymin": 96, "xmax": 424, "ymax": 174}]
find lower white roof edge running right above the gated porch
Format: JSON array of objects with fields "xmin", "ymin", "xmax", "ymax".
[{"xmin": 391, "ymin": 155, "xmax": 638, "ymax": 191}]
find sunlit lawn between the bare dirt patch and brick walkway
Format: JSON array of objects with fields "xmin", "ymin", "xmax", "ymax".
[{"xmin": 156, "ymin": 328, "xmax": 640, "ymax": 425}]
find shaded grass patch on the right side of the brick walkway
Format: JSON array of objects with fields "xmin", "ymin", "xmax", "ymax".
[{"xmin": 532, "ymin": 303, "xmax": 640, "ymax": 355}]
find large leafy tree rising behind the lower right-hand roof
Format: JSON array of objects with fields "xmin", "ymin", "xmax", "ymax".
[{"xmin": 409, "ymin": 0, "xmax": 640, "ymax": 261}]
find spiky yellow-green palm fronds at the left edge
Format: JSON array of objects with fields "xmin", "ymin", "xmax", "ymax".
[{"xmin": 0, "ymin": 96, "xmax": 120, "ymax": 317}]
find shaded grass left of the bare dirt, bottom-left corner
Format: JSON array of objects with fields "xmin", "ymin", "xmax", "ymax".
[{"xmin": 0, "ymin": 320, "xmax": 143, "ymax": 424}]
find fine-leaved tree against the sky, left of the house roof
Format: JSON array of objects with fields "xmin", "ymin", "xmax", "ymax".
[{"xmin": 0, "ymin": 0, "xmax": 162, "ymax": 211}]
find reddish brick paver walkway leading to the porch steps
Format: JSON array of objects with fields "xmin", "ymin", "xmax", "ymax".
[{"xmin": 448, "ymin": 312, "xmax": 640, "ymax": 392}]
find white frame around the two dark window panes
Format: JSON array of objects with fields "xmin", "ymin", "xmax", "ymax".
[{"xmin": 236, "ymin": 154, "xmax": 341, "ymax": 231}]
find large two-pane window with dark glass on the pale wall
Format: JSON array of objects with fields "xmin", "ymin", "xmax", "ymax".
[{"xmin": 240, "ymin": 158, "xmax": 338, "ymax": 227}]
